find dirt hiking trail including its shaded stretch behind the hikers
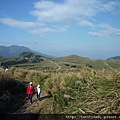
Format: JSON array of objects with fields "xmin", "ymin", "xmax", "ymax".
[{"xmin": 12, "ymin": 79, "xmax": 51, "ymax": 114}]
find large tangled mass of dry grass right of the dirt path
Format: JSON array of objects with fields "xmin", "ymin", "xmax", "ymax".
[{"xmin": 40, "ymin": 68, "xmax": 120, "ymax": 114}]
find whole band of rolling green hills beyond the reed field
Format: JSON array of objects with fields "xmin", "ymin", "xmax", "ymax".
[{"xmin": 1, "ymin": 52, "xmax": 120, "ymax": 71}]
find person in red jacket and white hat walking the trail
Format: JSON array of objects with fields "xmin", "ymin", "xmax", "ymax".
[{"xmin": 26, "ymin": 82, "xmax": 35, "ymax": 104}]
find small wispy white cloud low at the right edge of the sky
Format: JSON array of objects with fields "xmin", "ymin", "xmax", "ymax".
[{"xmin": 89, "ymin": 23, "xmax": 120, "ymax": 37}]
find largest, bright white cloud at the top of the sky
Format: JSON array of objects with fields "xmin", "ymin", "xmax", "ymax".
[{"xmin": 30, "ymin": 0, "xmax": 120, "ymax": 23}]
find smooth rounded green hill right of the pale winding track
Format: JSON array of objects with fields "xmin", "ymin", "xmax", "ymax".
[{"xmin": 53, "ymin": 55, "xmax": 120, "ymax": 70}]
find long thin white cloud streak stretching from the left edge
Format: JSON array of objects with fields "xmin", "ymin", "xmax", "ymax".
[{"xmin": 0, "ymin": 18, "xmax": 67, "ymax": 34}]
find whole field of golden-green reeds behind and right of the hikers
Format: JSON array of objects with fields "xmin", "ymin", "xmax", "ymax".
[{"xmin": 1, "ymin": 66, "xmax": 120, "ymax": 114}]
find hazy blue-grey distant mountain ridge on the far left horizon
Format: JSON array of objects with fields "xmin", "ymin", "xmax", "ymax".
[{"xmin": 0, "ymin": 45, "xmax": 53, "ymax": 58}]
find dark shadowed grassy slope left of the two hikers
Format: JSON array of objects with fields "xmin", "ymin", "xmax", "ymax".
[{"xmin": 0, "ymin": 70, "xmax": 26, "ymax": 113}]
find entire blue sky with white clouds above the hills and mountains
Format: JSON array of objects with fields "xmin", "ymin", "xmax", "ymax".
[{"xmin": 0, "ymin": 0, "xmax": 120, "ymax": 59}]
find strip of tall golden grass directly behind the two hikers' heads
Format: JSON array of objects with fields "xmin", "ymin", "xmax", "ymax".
[{"xmin": 9, "ymin": 67, "xmax": 50, "ymax": 86}]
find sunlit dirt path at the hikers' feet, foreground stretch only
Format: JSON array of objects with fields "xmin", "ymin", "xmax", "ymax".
[{"xmin": 13, "ymin": 91, "xmax": 50, "ymax": 114}]
